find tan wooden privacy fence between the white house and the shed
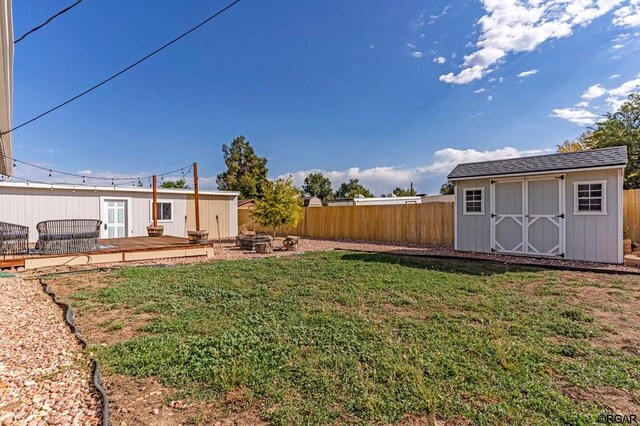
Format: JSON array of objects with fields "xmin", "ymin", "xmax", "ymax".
[{"xmin": 238, "ymin": 203, "xmax": 454, "ymax": 245}]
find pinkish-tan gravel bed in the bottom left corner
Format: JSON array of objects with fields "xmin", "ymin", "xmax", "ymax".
[{"xmin": 0, "ymin": 278, "xmax": 101, "ymax": 426}]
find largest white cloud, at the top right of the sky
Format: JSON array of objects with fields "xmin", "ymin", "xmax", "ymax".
[{"xmin": 440, "ymin": 0, "xmax": 624, "ymax": 84}]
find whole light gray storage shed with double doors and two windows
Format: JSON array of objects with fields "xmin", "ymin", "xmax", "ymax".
[{"xmin": 448, "ymin": 146, "xmax": 627, "ymax": 263}]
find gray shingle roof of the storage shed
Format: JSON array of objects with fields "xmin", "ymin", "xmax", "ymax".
[{"xmin": 448, "ymin": 146, "xmax": 627, "ymax": 179}]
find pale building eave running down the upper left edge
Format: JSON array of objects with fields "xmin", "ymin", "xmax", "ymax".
[{"xmin": 0, "ymin": 0, "xmax": 13, "ymax": 176}]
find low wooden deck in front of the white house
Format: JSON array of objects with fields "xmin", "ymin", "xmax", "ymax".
[{"xmin": 0, "ymin": 235, "xmax": 213, "ymax": 269}]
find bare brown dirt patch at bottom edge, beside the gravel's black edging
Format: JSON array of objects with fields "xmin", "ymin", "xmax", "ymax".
[{"xmin": 105, "ymin": 375, "xmax": 265, "ymax": 426}]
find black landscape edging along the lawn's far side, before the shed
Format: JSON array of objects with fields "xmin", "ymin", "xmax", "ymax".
[{"xmin": 334, "ymin": 248, "xmax": 640, "ymax": 275}]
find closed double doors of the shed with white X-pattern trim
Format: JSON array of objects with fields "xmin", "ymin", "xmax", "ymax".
[{"xmin": 491, "ymin": 176, "xmax": 565, "ymax": 257}]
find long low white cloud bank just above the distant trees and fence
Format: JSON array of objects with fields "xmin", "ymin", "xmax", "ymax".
[{"xmin": 278, "ymin": 147, "xmax": 550, "ymax": 194}]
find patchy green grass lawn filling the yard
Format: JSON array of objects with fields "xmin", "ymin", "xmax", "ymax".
[{"xmin": 61, "ymin": 252, "xmax": 640, "ymax": 424}]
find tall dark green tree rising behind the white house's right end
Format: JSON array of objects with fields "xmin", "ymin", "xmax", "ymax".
[{"xmin": 216, "ymin": 136, "xmax": 269, "ymax": 198}]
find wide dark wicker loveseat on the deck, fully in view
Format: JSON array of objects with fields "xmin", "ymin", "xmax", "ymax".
[{"xmin": 36, "ymin": 219, "xmax": 102, "ymax": 254}]
